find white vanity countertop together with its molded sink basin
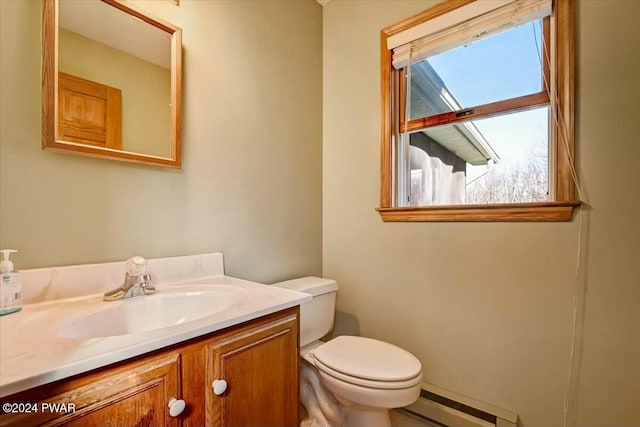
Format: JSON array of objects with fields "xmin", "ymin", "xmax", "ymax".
[{"xmin": 0, "ymin": 270, "xmax": 311, "ymax": 400}]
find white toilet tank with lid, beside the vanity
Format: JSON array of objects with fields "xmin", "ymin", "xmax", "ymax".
[{"xmin": 272, "ymin": 276, "xmax": 338, "ymax": 347}]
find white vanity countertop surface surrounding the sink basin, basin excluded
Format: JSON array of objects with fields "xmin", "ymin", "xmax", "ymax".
[{"xmin": 0, "ymin": 275, "xmax": 311, "ymax": 397}]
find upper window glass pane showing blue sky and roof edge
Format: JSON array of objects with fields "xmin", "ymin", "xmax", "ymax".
[{"xmin": 409, "ymin": 20, "xmax": 543, "ymax": 119}]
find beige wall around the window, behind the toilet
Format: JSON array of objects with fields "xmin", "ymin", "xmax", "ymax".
[{"xmin": 323, "ymin": 0, "xmax": 640, "ymax": 426}]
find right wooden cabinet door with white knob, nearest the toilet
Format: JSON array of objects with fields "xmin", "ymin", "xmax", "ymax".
[{"xmin": 205, "ymin": 307, "xmax": 299, "ymax": 427}]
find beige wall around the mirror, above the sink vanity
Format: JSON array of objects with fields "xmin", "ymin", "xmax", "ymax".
[{"xmin": 0, "ymin": 0, "xmax": 322, "ymax": 281}]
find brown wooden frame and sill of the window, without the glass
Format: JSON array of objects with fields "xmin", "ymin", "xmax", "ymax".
[{"xmin": 376, "ymin": 0, "xmax": 581, "ymax": 222}]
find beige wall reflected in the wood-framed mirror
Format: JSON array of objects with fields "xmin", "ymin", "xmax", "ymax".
[{"xmin": 58, "ymin": 28, "xmax": 171, "ymax": 157}]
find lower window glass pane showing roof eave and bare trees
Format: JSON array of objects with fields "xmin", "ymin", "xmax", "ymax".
[{"xmin": 408, "ymin": 107, "xmax": 549, "ymax": 206}]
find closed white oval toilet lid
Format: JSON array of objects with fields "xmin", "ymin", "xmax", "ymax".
[{"xmin": 314, "ymin": 335, "xmax": 422, "ymax": 381}]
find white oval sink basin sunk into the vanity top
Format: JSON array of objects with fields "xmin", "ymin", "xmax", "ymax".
[{"xmin": 17, "ymin": 285, "xmax": 247, "ymax": 338}]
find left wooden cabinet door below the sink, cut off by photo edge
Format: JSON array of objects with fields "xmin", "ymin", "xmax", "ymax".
[{"xmin": 0, "ymin": 353, "xmax": 180, "ymax": 427}]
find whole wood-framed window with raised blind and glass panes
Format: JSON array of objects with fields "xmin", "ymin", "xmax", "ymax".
[{"xmin": 377, "ymin": 0, "xmax": 580, "ymax": 221}]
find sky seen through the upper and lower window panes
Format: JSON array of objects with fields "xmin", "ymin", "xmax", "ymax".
[{"xmin": 418, "ymin": 21, "xmax": 548, "ymax": 172}]
